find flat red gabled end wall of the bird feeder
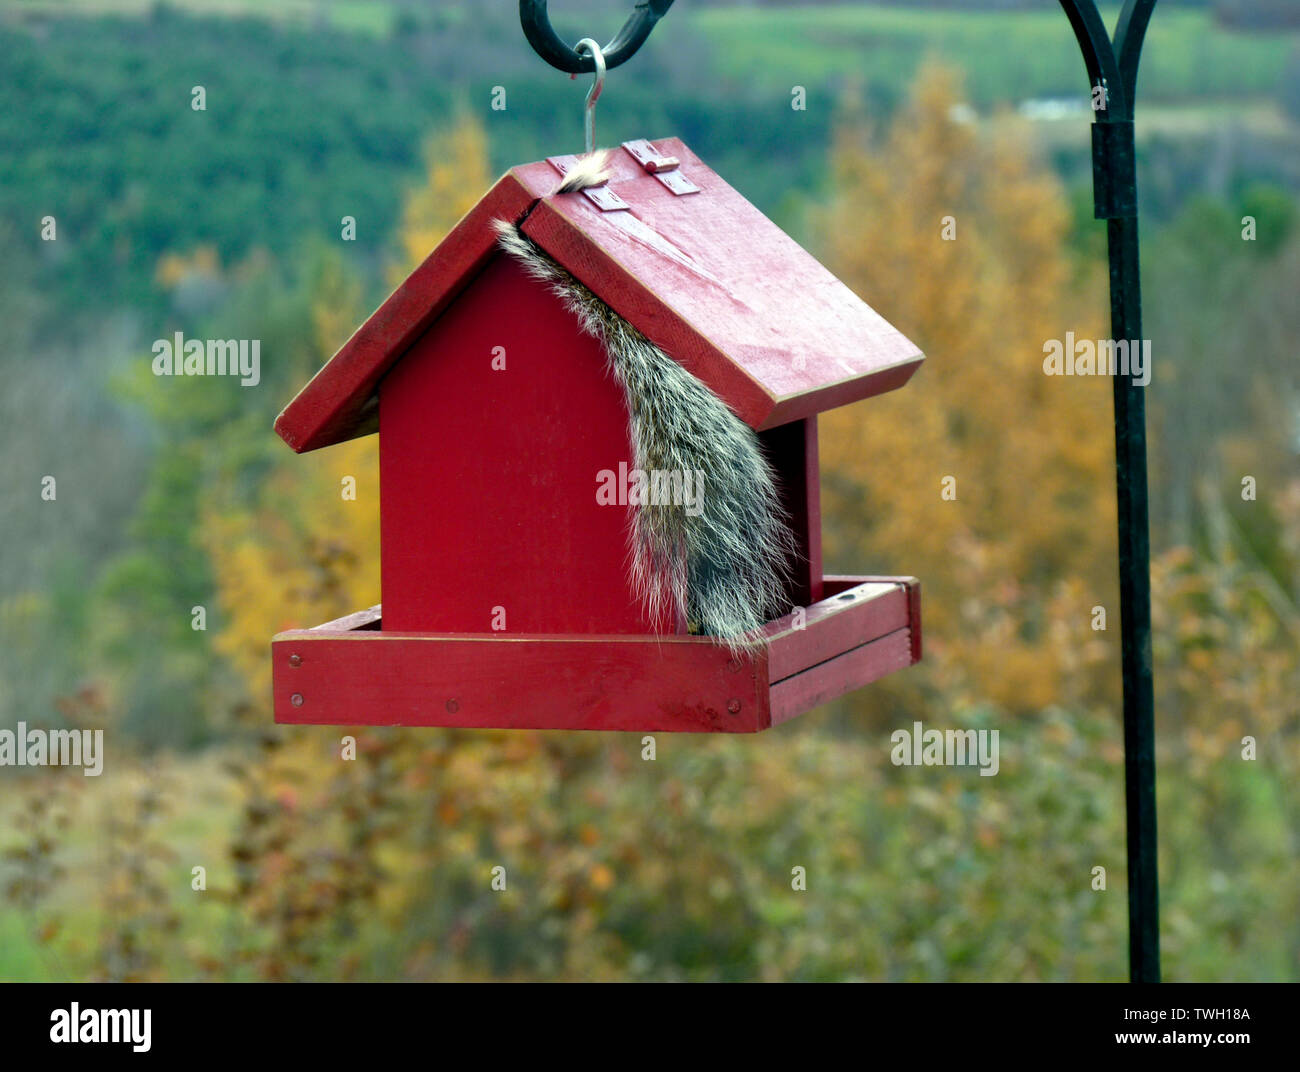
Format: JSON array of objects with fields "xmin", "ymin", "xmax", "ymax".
[{"xmin": 380, "ymin": 255, "xmax": 677, "ymax": 634}]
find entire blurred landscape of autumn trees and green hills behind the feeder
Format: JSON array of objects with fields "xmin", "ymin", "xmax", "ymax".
[{"xmin": 0, "ymin": 0, "xmax": 1300, "ymax": 980}]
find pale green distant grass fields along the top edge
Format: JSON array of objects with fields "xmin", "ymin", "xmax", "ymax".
[{"xmin": 10, "ymin": 0, "xmax": 1300, "ymax": 105}]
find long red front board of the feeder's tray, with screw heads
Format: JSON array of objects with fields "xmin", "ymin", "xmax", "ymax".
[{"xmin": 272, "ymin": 630, "xmax": 768, "ymax": 733}]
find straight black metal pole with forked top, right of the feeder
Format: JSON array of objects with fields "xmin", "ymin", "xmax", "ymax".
[{"xmin": 1061, "ymin": 0, "xmax": 1160, "ymax": 982}]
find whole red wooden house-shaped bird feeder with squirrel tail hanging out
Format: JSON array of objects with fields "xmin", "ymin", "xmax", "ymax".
[{"xmin": 272, "ymin": 139, "xmax": 922, "ymax": 733}]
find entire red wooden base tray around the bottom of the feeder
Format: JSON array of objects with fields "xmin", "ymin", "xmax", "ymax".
[{"xmin": 272, "ymin": 577, "xmax": 920, "ymax": 733}]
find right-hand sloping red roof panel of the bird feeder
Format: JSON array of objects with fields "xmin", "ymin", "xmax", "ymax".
[{"xmin": 524, "ymin": 138, "xmax": 922, "ymax": 429}]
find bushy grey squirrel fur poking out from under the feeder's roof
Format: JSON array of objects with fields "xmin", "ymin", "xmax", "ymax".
[{"xmin": 494, "ymin": 170, "xmax": 796, "ymax": 652}]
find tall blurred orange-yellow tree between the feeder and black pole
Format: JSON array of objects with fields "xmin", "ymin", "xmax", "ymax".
[{"xmin": 822, "ymin": 66, "xmax": 1118, "ymax": 711}]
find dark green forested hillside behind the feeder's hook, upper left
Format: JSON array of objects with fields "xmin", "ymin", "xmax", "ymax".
[{"xmin": 0, "ymin": 9, "xmax": 828, "ymax": 323}]
